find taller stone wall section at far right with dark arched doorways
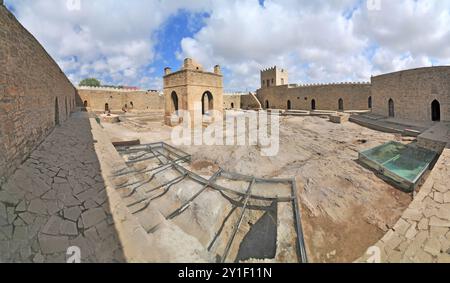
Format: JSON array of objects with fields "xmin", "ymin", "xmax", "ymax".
[{"xmin": 372, "ymin": 67, "xmax": 450, "ymax": 121}]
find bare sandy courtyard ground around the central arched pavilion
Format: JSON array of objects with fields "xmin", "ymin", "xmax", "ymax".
[{"xmin": 103, "ymin": 113, "xmax": 411, "ymax": 262}]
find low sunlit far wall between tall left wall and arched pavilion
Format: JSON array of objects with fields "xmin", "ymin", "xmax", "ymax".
[{"xmin": 77, "ymin": 87, "xmax": 164, "ymax": 112}]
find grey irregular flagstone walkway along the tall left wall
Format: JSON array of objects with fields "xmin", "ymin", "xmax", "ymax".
[{"xmin": 0, "ymin": 113, "xmax": 125, "ymax": 263}]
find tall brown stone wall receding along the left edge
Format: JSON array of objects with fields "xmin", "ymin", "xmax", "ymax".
[{"xmin": 0, "ymin": 5, "xmax": 76, "ymax": 184}]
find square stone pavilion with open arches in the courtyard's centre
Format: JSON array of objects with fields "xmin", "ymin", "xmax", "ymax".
[{"xmin": 164, "ymin": 58, "xmax": 223, "ymax": 126}]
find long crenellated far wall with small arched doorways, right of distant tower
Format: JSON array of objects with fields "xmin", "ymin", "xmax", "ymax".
[{"xmin": 257, "ymin": 83, "xmax": 371, "ymax": 111}]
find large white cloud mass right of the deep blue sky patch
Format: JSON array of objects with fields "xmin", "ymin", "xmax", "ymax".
[{"xmin": 180, "ymin": 0, "xmax": 450, "ymax": 89}]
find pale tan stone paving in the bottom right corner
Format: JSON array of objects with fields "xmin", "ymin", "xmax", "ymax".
[{"xmin": 358, "ymin": 144, "xmax": 450, "ymax": 263}]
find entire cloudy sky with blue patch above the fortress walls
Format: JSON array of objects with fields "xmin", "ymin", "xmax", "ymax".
[{"xmin": 5, "ymin": 0, "xmax": 450, "ymax": 91}]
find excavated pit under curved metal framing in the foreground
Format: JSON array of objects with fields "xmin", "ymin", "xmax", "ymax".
[{"xmin": 110, "ymin": 143, "xmax": 307, "ymax": 262}]
